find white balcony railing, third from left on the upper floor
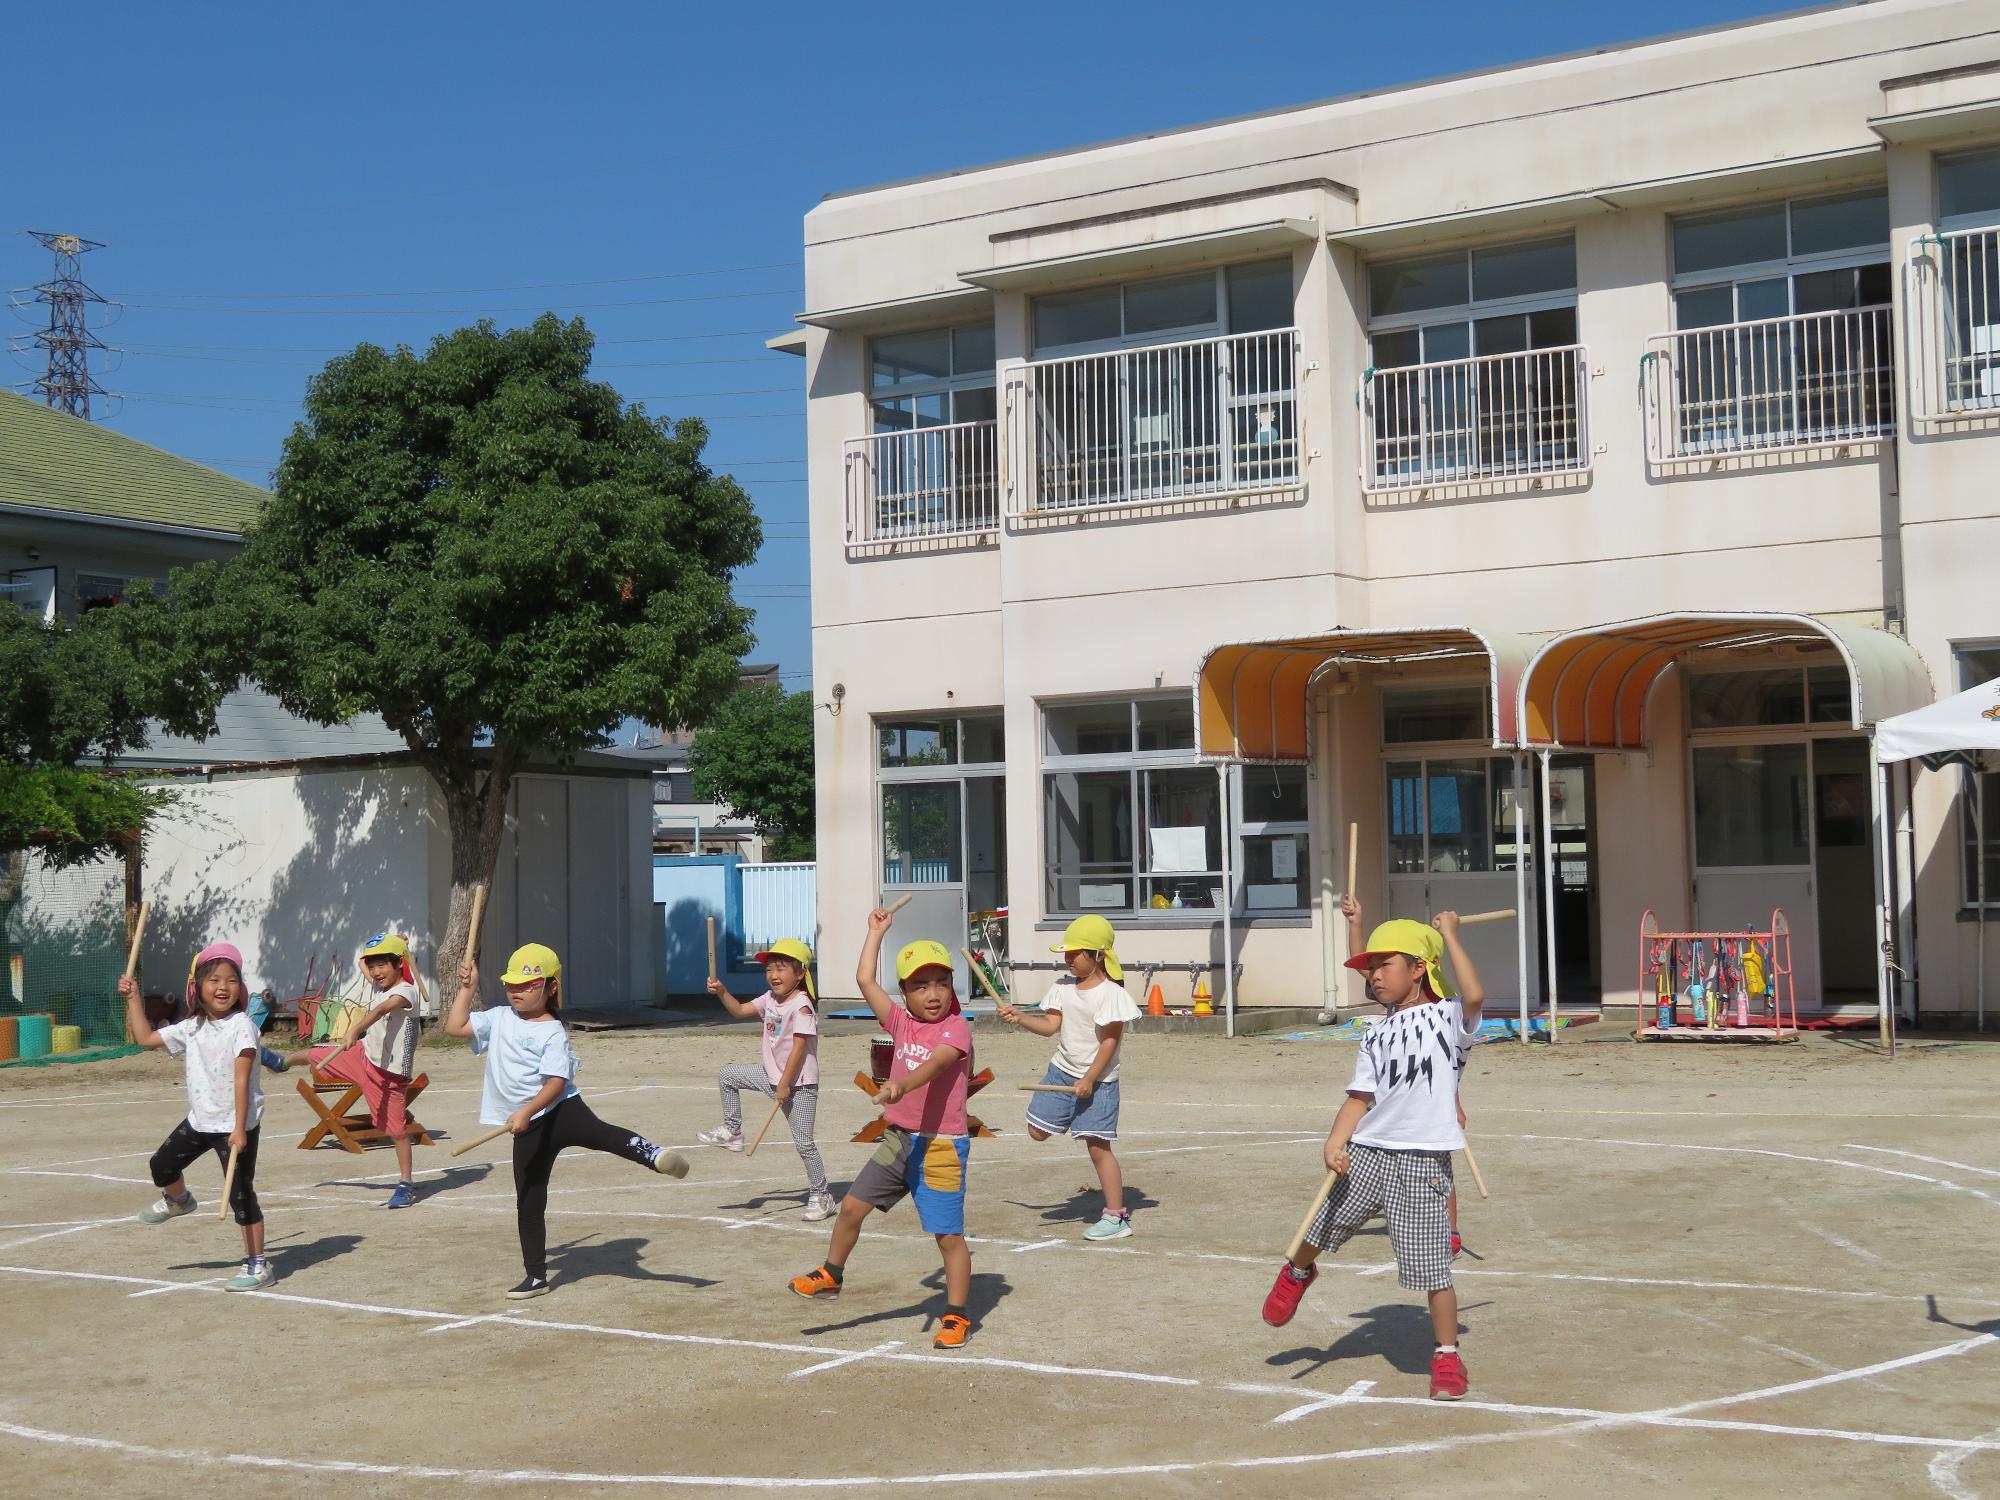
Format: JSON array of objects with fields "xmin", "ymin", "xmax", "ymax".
[{"xmin": 1360, "ymin": 344, "xmax": 1590, "ymax": 492}]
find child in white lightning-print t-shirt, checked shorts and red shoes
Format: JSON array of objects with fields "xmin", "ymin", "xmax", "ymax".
[{"xmin": 1264, "ymin": 912, "xmax": 1486, "ymax": 1400}]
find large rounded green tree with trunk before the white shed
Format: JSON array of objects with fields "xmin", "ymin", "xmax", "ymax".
[{"xmin": 174, "ymin": 314, "xmax": 762, "ymax": 972}]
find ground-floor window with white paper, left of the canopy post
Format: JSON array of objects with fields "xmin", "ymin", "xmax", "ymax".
[{"xmin": 1042, "ymin": 694, "xmax": 1222, "ymax": 916}]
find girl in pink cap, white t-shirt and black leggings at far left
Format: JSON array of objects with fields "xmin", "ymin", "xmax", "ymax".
[{"xmin": 118, "ymin": 942, "xmax": 272, "ymax": 1292}]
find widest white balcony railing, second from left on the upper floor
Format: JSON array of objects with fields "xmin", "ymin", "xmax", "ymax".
[{"xmin": 1008, "ymin": 328, "xmax": 1304, "ymax": 514}]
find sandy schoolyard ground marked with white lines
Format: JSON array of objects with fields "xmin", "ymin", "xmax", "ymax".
[{"xmin": 0, "ymin": 1024, "xmax": 2000, "ymax": 1496}]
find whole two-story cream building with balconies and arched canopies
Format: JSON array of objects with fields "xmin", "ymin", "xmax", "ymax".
[{"xmin": 774, "ymin": 0, "xmax": 2000, "ymax": 1022}]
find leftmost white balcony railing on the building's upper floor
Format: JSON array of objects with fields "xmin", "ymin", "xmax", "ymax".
[{"xmin": 846, "ymin": 422, "xmax": 1000, "ymax": 548}]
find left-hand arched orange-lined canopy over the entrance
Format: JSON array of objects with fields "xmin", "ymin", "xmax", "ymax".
[{"xmin": 1194, "ymin": 626, "xmax": 1542, "ymax": 764}]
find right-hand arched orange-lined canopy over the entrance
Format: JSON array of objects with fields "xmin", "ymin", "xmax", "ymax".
[{"xmin": 1518, "ymin": 614, "xmax": 1930, "ymax": 750}]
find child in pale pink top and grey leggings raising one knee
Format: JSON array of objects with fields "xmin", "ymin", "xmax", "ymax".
[{"xmin": 696, "ymin": 938, "xmax": 834, "ymax": 1222}]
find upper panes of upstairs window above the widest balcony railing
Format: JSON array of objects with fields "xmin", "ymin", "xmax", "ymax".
[{"xmin": 1034, "ymin": 260, "xmax": 1292, "ymax": 356}]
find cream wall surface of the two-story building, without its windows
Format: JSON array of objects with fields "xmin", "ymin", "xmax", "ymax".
[{"xmin": 804, "ymin": 0, "xmax": 2000, "ymax": 1012}]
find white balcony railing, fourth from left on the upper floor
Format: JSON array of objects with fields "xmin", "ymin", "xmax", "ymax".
[{"xmin": 1640, "ymin": 306, "xmax": 1896, "ymax": 464}]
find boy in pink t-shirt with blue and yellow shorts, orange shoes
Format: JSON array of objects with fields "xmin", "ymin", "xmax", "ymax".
[{"xmin": 792, "ymin": 906, "xmax": 972, "ymax": 1348}]
